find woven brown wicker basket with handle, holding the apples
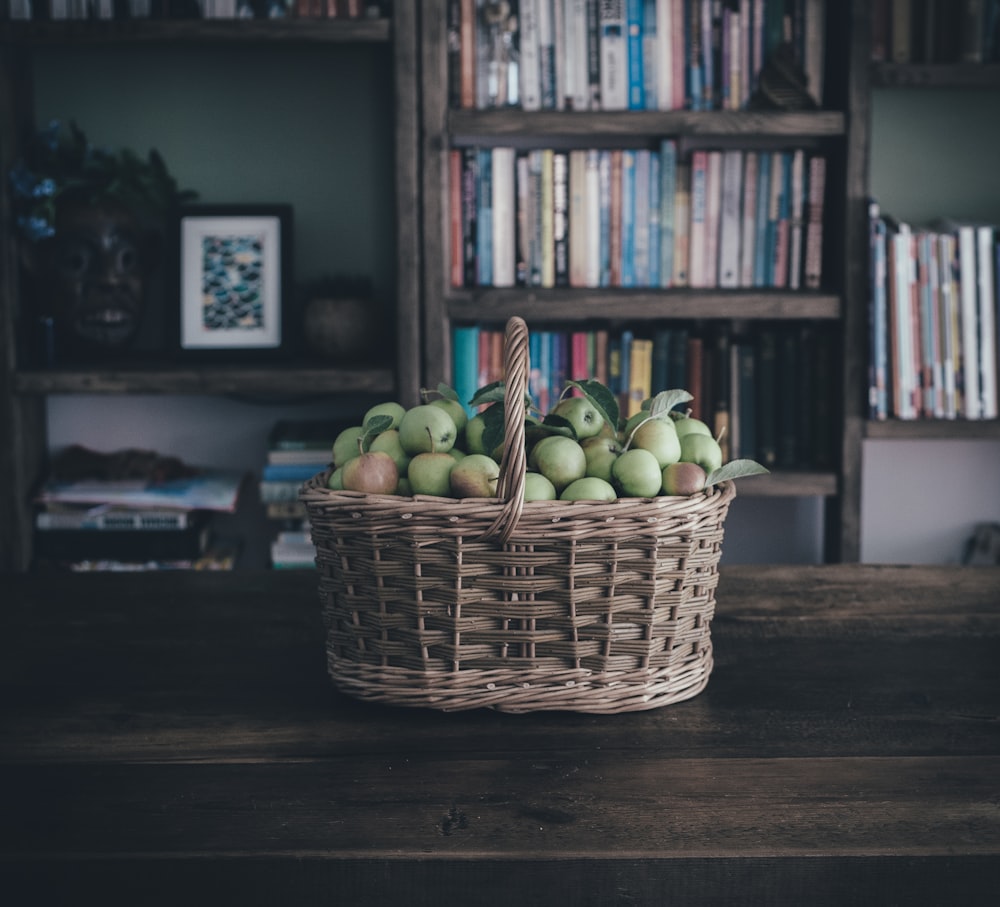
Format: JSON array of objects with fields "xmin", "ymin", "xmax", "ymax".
[{"xmin": 301, "ymin": 318, "xmax": 735, "ymax": 713}]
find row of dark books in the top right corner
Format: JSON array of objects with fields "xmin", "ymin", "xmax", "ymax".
[{"xmin": 871, "ymin": 0, "xmax": 1000, "ymax": 63}]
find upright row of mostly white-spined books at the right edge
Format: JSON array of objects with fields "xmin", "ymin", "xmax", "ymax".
[{"xmin": 869, "ymin": 201, "xmax": 1000, "ymax": 420}]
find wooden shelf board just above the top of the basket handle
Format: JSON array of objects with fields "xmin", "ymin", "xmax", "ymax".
[{"xmin": 446, "ymin": 287, "xmax": 841, "ymax": 322}]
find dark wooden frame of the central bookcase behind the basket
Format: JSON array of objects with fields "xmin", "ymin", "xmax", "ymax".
[{"xmin": 421, "ymin": 2, "xmax": 867, "ymax": 561}]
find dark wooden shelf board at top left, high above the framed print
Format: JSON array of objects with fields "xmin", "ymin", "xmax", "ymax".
[{"xmin": 0, "ymin": 18, "xmax": 392, "ymax": 45}]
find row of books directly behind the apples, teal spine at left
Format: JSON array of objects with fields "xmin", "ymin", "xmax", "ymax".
[{"xmin": 453, "ymin": 322, "xmax": 837, "ymax": 469}]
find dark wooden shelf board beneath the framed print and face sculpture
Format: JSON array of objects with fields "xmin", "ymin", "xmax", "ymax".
[{"xmin": 14, "ymin": 366, "xmax": 395, "ymax": 397}]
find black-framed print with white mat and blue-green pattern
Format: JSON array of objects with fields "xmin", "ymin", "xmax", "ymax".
[{"xmin": 178, "ymin": 205, "xmax": 292, "ymax": 355}]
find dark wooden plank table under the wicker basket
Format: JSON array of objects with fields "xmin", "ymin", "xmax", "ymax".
[{"xmin": 0, "ymin": 566, "xmax": 1000, "ymax": 907}]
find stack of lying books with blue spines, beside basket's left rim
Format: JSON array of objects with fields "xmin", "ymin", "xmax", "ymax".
[{"xmin": 259, "ymin": 419, "xmax": 345, "ymax": 569}]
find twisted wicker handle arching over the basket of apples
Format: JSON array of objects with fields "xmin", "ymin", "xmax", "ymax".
[{"xmin": 482, "ymin": 315, "xmax": 529, "ymax": 543}]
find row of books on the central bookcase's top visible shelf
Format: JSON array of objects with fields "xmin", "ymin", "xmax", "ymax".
[{"xmin": 448, "ymin": 0, "xmax": 826, "ymax": 110}]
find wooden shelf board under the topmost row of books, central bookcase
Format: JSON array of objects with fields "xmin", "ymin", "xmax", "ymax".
[{"xmin": 448, "ymin": 107, "xmax": 845, "ymax": 139}]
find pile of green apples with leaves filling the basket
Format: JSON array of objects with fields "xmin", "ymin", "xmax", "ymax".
[{"xmin": 327, "ymin": 381, "xmax": 767, "ymax": 501}]
